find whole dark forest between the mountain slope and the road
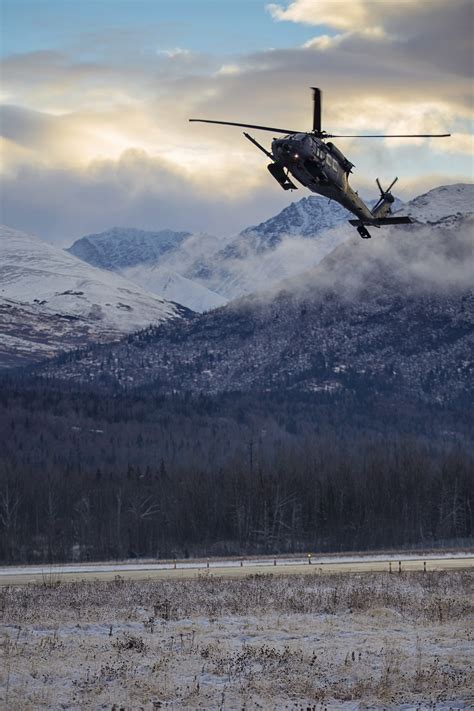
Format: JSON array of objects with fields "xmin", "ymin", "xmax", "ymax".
[{"xmin": 0, "ymin": 374, "xmax": 474, "ymax": 563}]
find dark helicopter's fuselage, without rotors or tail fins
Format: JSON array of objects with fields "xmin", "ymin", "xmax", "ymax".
[{"xmin": 272, "ymin": 133, "xmax": 376, "ymax": 224}]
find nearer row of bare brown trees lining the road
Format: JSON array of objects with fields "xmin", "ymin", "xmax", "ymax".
[{"xmin": 0, "ymin": 440, "xmax": 474, "ymax": 562}]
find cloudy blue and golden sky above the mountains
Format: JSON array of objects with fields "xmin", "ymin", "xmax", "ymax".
[{"xmin": 0, "ymin": 0, "xmax": 474, "ymax": 245}]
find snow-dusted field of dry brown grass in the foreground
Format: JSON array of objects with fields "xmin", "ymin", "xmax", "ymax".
[{"xmin": 0, "ymin": 571, "xmax": 474, "ymax": 711}]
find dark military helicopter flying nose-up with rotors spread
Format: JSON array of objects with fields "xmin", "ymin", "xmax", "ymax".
[{"xmin": 189, "ymin": 87, "xmax": 451, "ymax": 239}]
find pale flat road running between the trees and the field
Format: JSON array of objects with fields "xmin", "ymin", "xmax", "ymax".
[{"xmin": 0, "ymin": 553, "xmax": 474, "ymax": 587}]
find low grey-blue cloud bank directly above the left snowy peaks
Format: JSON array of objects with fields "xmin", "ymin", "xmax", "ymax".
[{"xmin": 0, "ymin": 145, "xmax": 284, "ymax": 246}]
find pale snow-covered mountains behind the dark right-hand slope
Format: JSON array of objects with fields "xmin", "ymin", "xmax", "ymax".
[{"xmin": 0, "ymin": 191, "xmax": 388, "ymax": 367}]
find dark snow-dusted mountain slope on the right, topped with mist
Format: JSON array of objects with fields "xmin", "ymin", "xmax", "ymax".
[{"xmin": 39, "ymin": 186, "xmax": 474, "ymax": 402}]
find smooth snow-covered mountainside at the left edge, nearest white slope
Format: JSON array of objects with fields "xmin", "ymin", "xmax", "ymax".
[{"xmin": 0, "ymin": 227, "xmax": 186, "ymax": 365}]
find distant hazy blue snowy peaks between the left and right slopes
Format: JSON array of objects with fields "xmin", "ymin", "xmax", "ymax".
[{"xmin": 64, "ymin": 195, "xmax": 402, "ymax": 312}]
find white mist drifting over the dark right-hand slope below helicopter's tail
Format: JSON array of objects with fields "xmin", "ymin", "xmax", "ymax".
[{"xmin": 266, "ymin": 215, "xmax": 474, "ymax": 309}]
